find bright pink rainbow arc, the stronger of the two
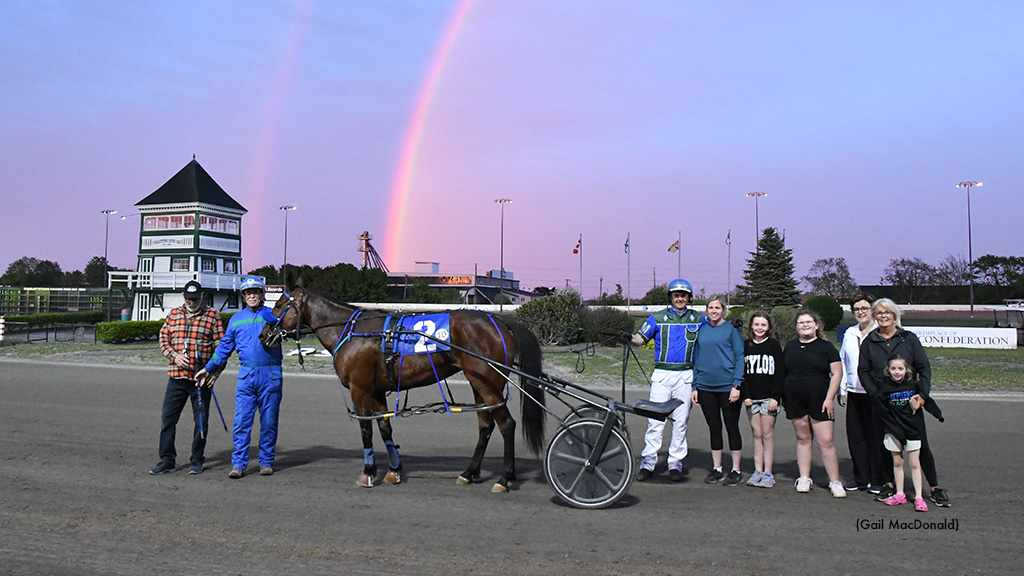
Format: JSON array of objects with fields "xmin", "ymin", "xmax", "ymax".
[{"xmin": 384, "ymin": 0, "xmax": 476, "ymax": 270}]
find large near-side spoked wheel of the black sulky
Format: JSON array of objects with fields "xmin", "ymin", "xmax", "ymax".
[{"xmin": 544, "ymin": 420, "xmax": 633, "ymax": 508}]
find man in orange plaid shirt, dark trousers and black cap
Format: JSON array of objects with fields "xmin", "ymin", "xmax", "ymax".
[{"xmin": 150, "ymin": 280, "xmax": 224, "ymax": 475}]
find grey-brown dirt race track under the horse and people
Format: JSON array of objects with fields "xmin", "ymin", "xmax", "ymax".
[{"xmin": 0, "ymin": 360, "xmax": 1024, "ymax": 575}]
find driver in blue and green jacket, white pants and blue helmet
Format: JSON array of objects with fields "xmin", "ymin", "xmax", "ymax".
[{"xmin": 633, "ymin": 278, "xmax": 702, "ymax": 482}]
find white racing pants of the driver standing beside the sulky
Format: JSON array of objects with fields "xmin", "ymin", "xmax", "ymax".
[{"xmin": 640, "ymin": 368, "xmax": 693, "ymax": 470}]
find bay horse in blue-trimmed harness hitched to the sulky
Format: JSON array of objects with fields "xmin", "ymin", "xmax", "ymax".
[{"xmin": 260, "ymin": 279, "xmax": 546, "ymax": 492}]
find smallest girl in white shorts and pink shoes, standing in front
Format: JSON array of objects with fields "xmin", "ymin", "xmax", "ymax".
[{"xmin": 881, "ymin": 353, "xmax": 928, "ymax": 512}]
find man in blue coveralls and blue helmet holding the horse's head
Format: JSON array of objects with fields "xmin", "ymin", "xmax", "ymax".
[{"xmin": 196, "ymin": 276, "xmax": 282, "ymax": 479}]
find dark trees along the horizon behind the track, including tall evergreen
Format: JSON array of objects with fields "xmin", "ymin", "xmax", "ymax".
[{"xmin": 0, "ymin": 241, "xmax": 1024, "ymax": 308}]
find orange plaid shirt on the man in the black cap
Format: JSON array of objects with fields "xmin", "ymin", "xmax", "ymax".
[{"xmin": 160, "ymin": 305, "xmax": 224, "ymax": 380}]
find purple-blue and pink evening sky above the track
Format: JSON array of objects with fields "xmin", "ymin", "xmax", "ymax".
[{"xmin": 0, "ymin": 0, "xmax": 1024, "ymax": 297}]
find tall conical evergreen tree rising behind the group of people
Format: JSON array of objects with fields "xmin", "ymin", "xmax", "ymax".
[{"xmin": 737, "ymin": 228, "xmax": 800, "ymax": 308}]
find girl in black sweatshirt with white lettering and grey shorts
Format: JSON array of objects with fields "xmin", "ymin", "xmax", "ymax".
[{"xmin": 739, "ymin": 311, "xmax": 785, "ymax": 488}]
